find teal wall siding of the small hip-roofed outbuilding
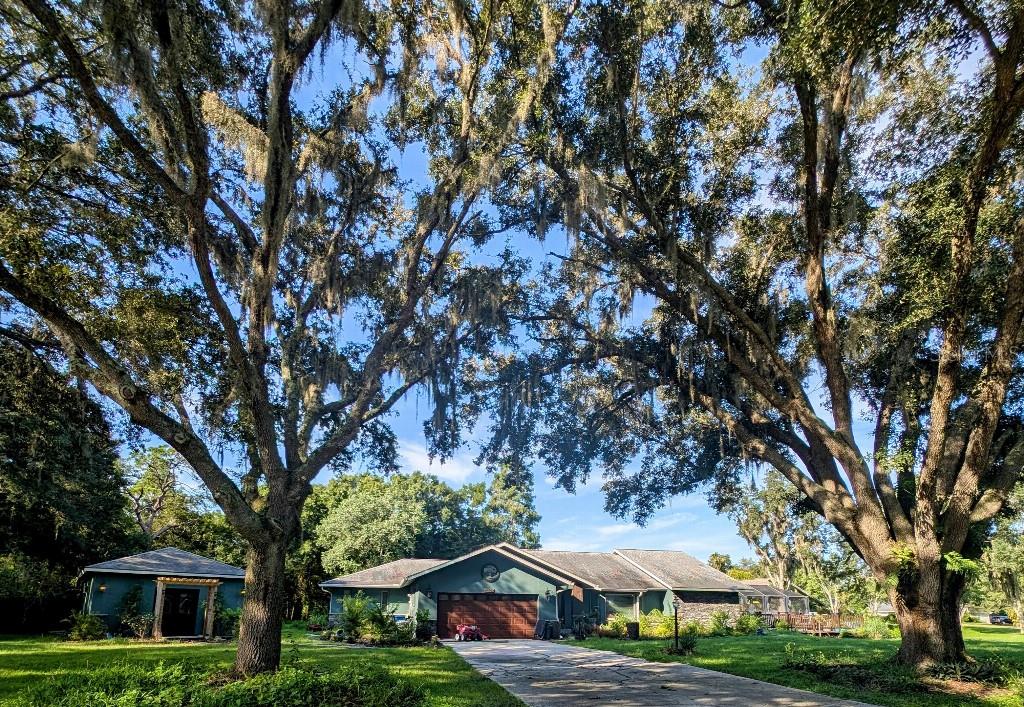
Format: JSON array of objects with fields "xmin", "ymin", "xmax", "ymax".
[{"xmin": 82, "ymin": 574, "xmax": 245, "ymax": 635}]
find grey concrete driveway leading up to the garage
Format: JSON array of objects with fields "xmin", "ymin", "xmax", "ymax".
[{"xmin": 450, "ymin": 640, "xmax": 865, "ymax": 707}]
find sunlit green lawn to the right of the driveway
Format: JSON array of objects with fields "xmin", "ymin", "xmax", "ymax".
[{"xmin": 586, "ymin": 625, "xmax": 1024, "ymax": 707}]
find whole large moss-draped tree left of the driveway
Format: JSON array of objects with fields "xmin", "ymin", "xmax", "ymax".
[{"xmin": 0, "ymin": 0, "xmax": 571, "ymax": 674}]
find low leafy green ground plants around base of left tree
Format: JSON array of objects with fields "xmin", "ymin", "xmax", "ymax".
[{"xmin": 8, "ymin": 663, "xmax": 424, "ymax": 707}]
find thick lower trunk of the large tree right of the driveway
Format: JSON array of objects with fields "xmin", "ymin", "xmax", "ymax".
[{"xmin": 891, "ymin": 571, "xmax": 967, "ymax": 668}]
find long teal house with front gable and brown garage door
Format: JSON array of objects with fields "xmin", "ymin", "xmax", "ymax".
[{"xmin": 321, "ymin": 543, "xmax": 751, "ymax": 638}]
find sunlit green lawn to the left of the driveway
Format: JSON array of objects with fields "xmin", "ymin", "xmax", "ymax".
[{"xmin": 0, "ymin": 623, "xmax": 522, "ymax": 707}]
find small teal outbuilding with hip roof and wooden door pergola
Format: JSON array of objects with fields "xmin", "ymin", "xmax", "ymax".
[{"xmin": 82, "ymin": 547, "xmax": 246, "ymax": 638}]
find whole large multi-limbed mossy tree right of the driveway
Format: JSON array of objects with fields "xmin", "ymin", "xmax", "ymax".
[{"xmin": 480, "ymin": 0, "xmax": 1024, "ymax": 666}]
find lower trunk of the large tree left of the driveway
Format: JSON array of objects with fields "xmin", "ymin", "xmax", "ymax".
[{"xmin": 234, "ymin": 540, "xmax": 288, "ymax": 675}]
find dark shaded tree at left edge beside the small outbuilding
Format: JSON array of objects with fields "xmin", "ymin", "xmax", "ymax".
[{"xmin": 0, "ymin": 338, "xmax": 135, "ymax": 630}]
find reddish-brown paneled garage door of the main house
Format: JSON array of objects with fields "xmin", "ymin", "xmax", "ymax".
[{"xmin": 437, "ymin": 594, "xmax": 537, "ymax": 638}]
